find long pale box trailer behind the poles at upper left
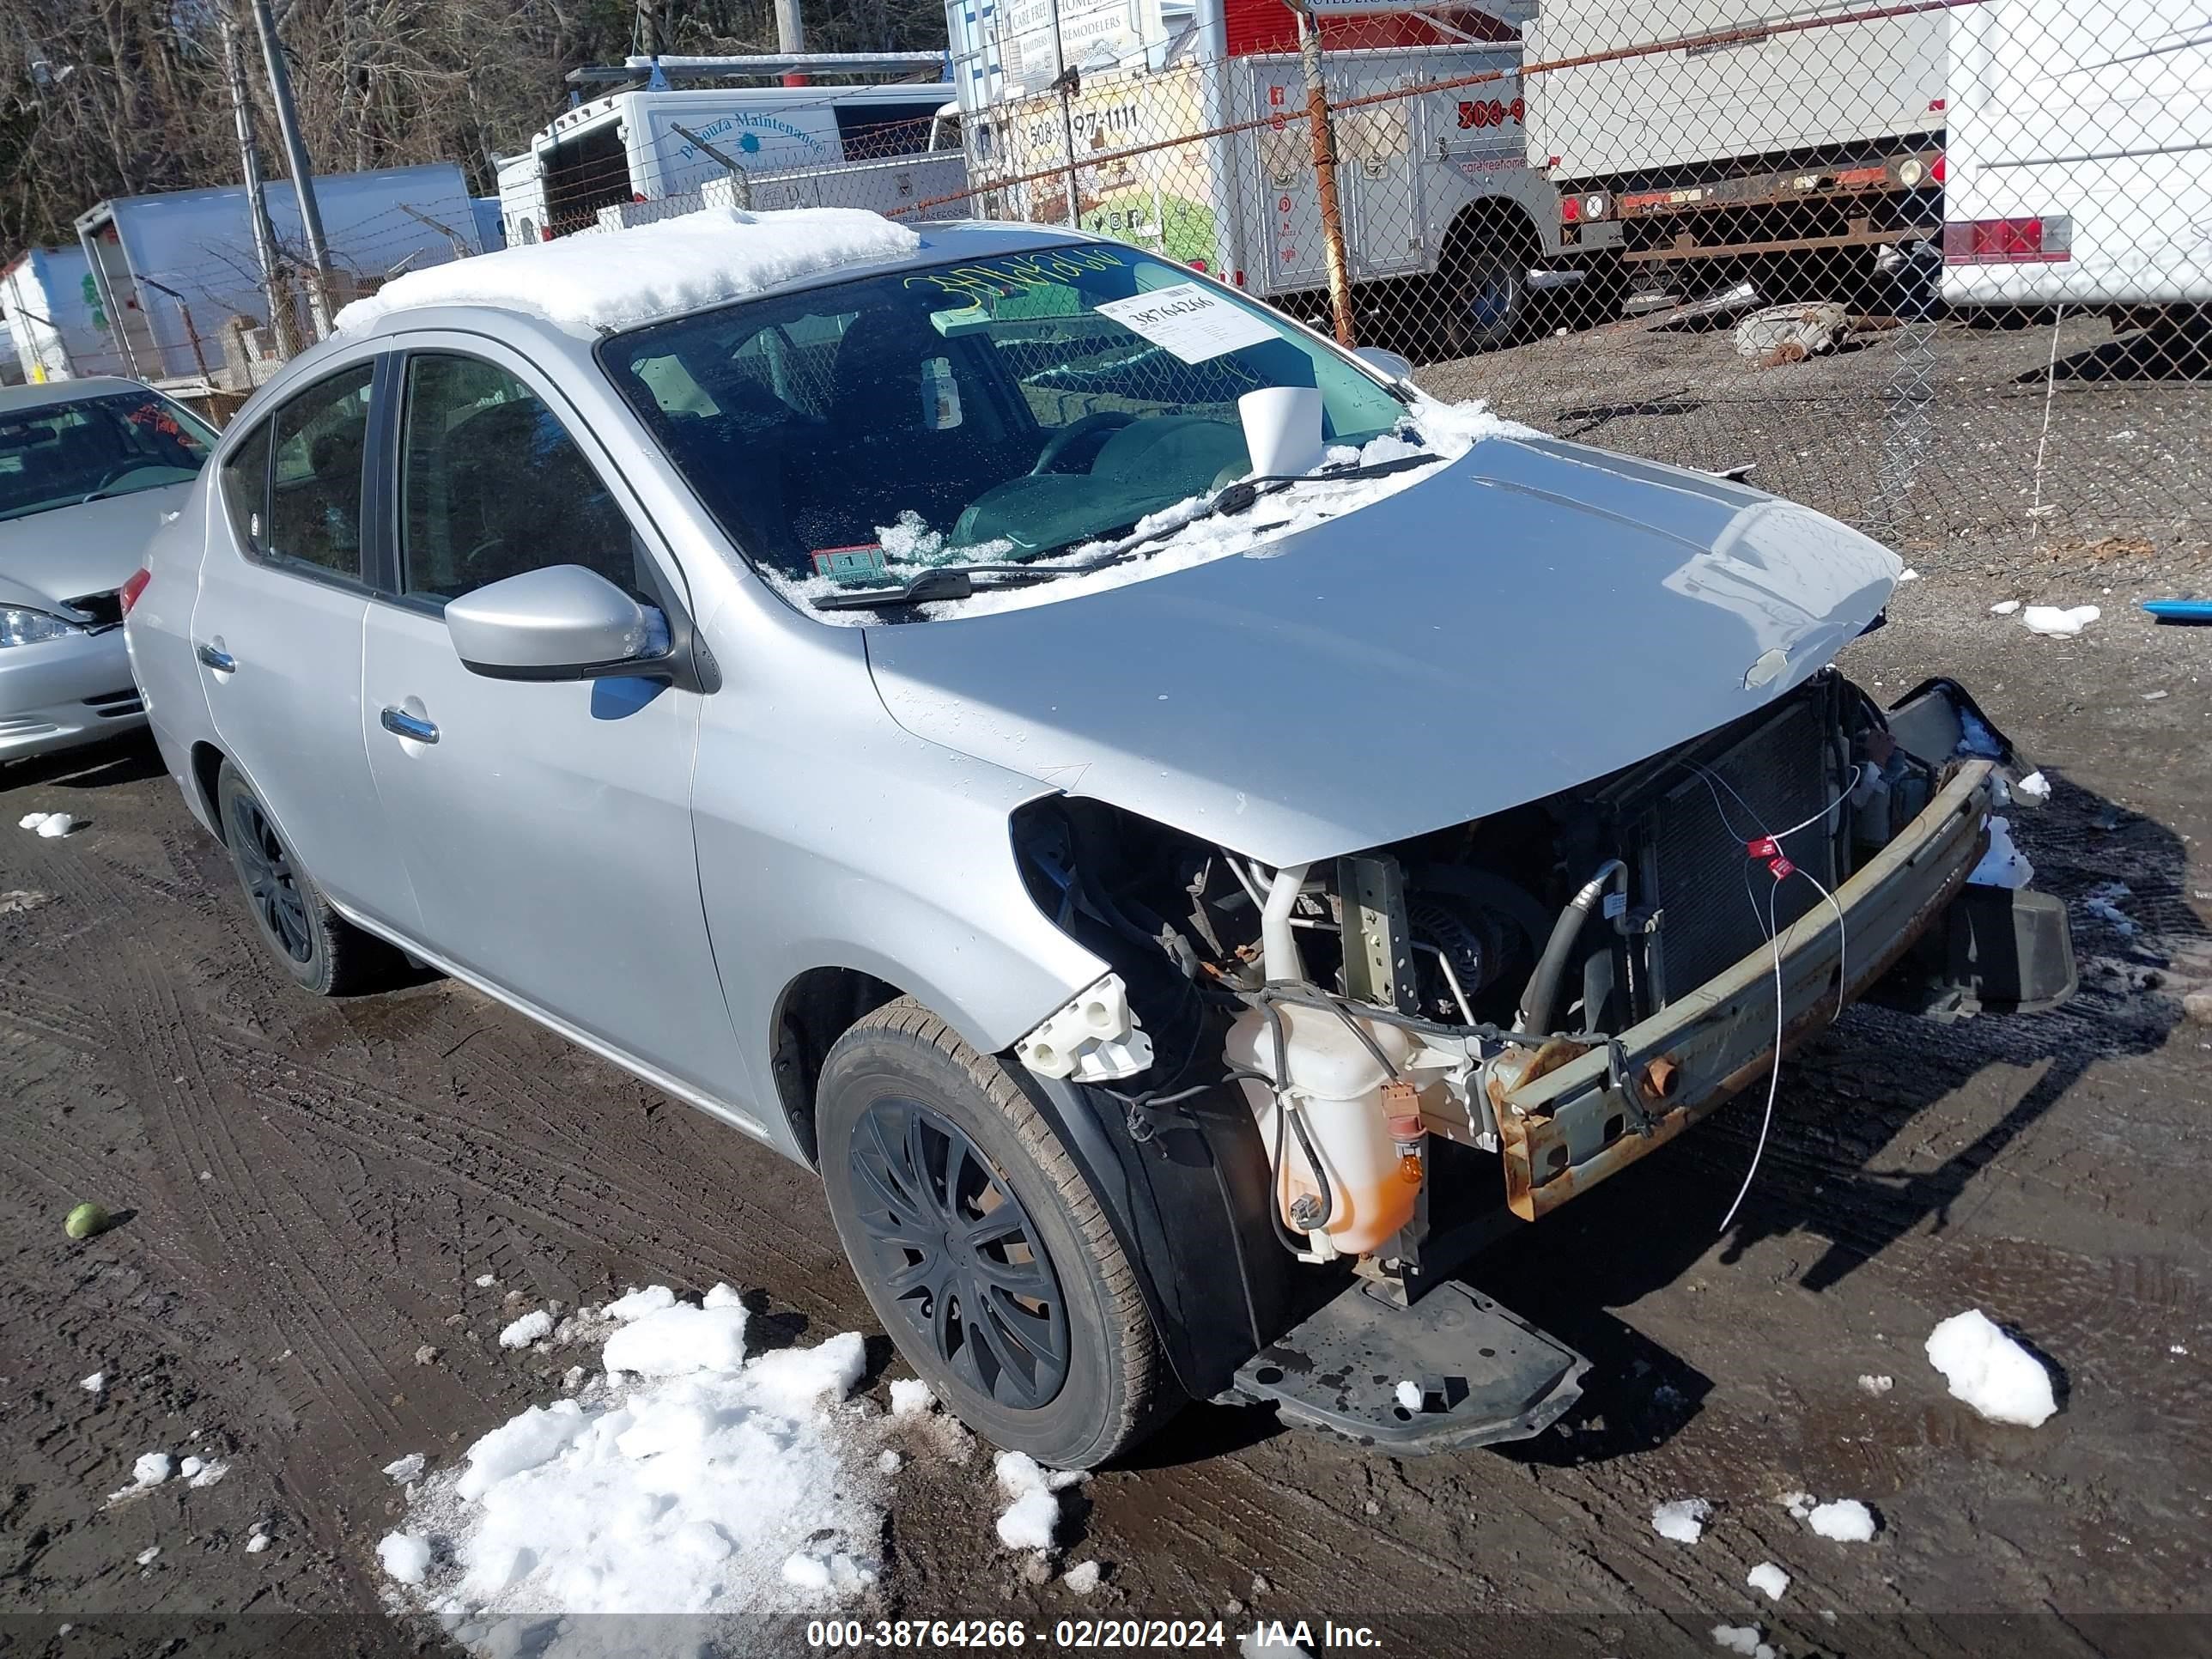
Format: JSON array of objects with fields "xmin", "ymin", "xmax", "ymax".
[{"xmin": 77, "ymin": 161, "xmax": 484, "ymax": 380}]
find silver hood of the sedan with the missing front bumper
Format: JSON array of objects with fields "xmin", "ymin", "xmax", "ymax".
[{"xmin": 867, "ymin": 438, "xmax": 1900, "ymax": 865}]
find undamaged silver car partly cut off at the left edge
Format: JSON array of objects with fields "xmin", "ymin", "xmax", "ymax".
[{"xmin": 0, "ymin": 378, "xmax": 215, "ymax": 761}]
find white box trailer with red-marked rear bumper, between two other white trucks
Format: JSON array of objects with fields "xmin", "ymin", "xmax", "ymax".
[{"xmin": 1528, "ymin": 0, "xmax": 1954, "ymax": 296}]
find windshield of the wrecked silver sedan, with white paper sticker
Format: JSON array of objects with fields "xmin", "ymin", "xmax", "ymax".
[{"xmin": 602, "ymin": 243, "xmax": 1407, "ymax": 605}]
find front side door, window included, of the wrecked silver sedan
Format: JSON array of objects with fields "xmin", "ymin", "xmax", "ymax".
[{"xmin": 362, "ymin": 337, "xmax": 741, "ymax": 1102}]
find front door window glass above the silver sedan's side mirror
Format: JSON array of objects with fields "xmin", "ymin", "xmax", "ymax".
[{"xmin": 400, "ymin": 352, "xmax": 657, "ymax": 604}]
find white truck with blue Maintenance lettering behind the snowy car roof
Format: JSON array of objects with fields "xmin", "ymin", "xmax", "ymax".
[{"xmin": 531, "ymin": 81, "xmax": 964, "ymax": 241}]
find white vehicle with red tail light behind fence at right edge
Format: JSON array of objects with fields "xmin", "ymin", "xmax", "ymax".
[{"xmin": 1942, "ymin": 0, "xmax": 2212, "ymax": 330}]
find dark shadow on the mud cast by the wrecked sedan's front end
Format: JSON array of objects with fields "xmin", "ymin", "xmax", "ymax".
[{"xmin": 1464, "ymin": 765, "xmax": 2212, "ymax": 1462}]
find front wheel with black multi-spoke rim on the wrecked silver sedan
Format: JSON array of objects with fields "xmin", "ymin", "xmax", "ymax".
[{"xmin": 817, "ymin": 998, "xmax": 1182, "ymax": 1468}]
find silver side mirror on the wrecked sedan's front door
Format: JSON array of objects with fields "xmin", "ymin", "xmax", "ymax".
[{"xmin": 445, "ymin": 564, "xmax": 672, "ymax": 679}]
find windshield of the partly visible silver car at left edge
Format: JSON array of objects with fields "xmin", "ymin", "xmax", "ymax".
[{"xmin": 0, "ymin": 392, "xmax": 215, "ymax": 520}]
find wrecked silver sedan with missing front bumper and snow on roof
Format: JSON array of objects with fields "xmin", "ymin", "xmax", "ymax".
[{"xmin": 128, "ymin": 212, "xmax": 2073, "ymax": 1467}]
